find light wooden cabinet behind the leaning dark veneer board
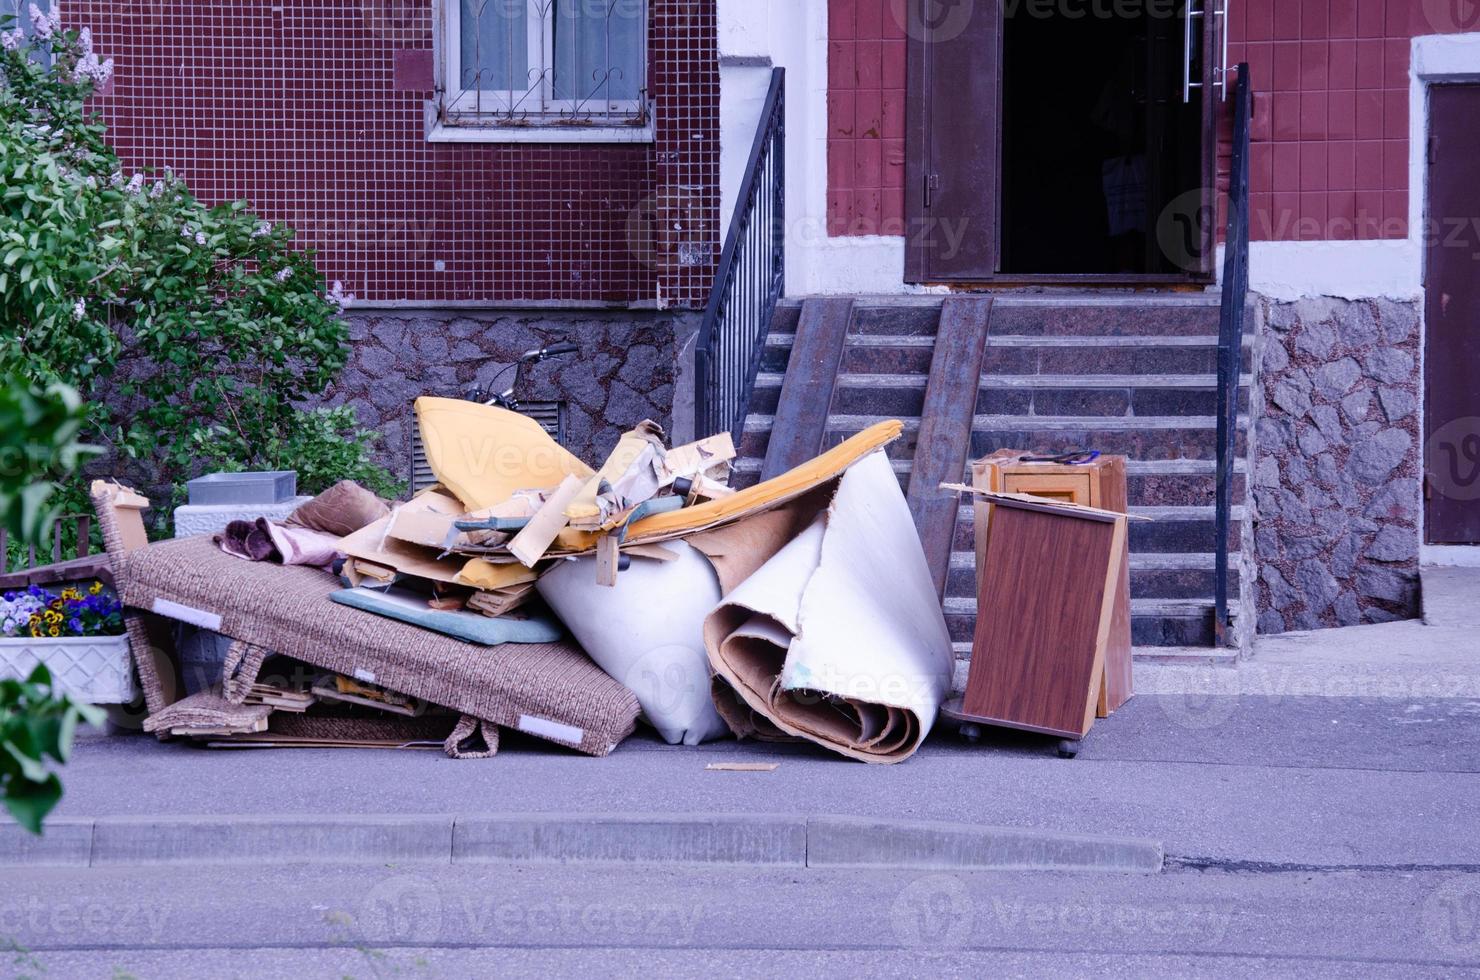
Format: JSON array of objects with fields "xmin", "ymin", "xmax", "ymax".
[{"xmin": 971, "ymin": 449, "xmax": 1132, "ymax": 718}]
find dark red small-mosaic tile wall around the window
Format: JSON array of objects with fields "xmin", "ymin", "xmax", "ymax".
[{"xmin": 72, "ymin": 0, "xmax": 719, "ymax": 306}]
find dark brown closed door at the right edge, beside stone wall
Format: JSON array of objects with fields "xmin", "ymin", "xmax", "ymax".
[{"xmin": 1424, "ymin": 84, "xmax": 1480, "ymax": 545}]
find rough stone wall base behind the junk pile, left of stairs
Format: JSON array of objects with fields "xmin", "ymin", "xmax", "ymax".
[{"xmin": 324, "ymin": 311, "xmax": 691, "ymax": 488}]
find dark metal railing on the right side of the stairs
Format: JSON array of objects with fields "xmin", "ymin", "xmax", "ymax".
[{"xmin": 1214, "ymin": 64, "xmax": 1254, "ymax": 644}]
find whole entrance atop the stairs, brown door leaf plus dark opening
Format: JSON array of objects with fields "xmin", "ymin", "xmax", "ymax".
[{"xmin": 906, "ymin": 0, "xmax": 1221, "ymax": 283}]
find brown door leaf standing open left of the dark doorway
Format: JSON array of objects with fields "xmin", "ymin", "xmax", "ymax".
[{"xmin": 904, "ymin": 0, "xmax": 1002, "ymax": 283}]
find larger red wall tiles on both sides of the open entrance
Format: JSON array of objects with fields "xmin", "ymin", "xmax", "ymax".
[{"xmin": 827, "ymin": 0, "xmax": 1480, "ymax": 240}]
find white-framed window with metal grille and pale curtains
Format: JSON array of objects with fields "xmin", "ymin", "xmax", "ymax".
[{"xmin": 440, "ymin": 0, "xmax": 647, "ymax": 127}]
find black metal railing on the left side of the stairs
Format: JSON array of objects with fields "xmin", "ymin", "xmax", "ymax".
[{"xmin": 694, "ymin": 68, "xmax": 786, "ymax": 443}]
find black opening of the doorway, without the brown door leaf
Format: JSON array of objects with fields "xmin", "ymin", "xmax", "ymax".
[{"xmin": 1000, "ymin": 4, "xmax": 1202, "ymax": 275}]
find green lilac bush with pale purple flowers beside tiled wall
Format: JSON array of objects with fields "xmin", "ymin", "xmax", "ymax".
[{"xmin": 0, "ymin": 16, "xmax": 394, "ymax": 506}]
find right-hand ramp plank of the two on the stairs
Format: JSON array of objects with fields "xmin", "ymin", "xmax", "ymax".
[{"xmin": 909, "ymin": 296, "xmax": 992, "ymax": 595}]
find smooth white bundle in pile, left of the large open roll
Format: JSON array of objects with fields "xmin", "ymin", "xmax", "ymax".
[{"xmin": 537, "ymin": 542, "xmax": 728, "ymax": 745}]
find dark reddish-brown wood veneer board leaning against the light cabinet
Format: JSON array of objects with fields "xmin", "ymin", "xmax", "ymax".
[{"xmin": 962, "ymin": 499, "xmax": 1126, "ymax": 739}]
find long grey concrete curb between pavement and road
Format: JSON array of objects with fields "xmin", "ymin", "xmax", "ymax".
[{"xmin": 0, "ymin": 814, "xmax": 1163, "ymax": 873}]
